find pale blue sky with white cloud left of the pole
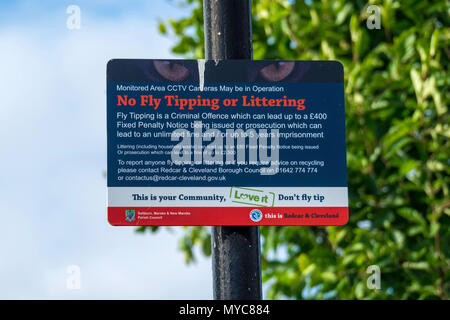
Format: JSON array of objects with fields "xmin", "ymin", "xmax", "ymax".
[{"xmin": 0, "ymin": 0, "xmax": 212, "ymax": 299}]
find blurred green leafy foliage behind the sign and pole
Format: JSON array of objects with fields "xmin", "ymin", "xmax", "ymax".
[{"xmin": 139, "ymin": 0, "xmax": 450, "ymax": 299}]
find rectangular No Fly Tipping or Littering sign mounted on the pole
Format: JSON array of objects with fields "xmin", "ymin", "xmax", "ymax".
[{"xmin": 107, "ymin": 59, "xmax": 348, "ymax": 225}]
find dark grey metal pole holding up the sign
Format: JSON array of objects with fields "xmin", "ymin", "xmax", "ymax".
[{"xmin": 203, "ymin": 0, "xmax": 262, "ymax": 300}]
